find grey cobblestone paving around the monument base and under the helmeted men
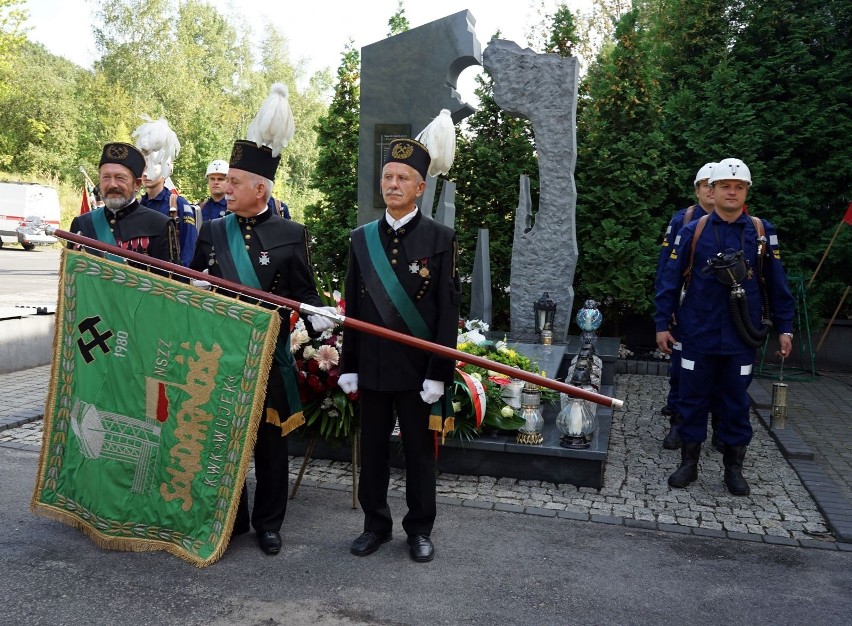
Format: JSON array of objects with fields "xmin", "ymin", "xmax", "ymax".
[{"xmin": 0, "ymin": 374, "xmax": 834, "ymax": 547}]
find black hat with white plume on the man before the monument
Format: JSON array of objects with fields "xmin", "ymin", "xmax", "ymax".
[{"xmin": 382, "ymin": 109, "xmax": 456, "ymax": 179}]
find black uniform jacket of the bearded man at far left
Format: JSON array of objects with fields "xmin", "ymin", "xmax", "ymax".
[{"xmin": 68, "ymin": 200, "xmax": 180, "ymax": 264}]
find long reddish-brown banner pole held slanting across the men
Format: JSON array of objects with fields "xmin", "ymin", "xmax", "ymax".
[{"xmin": 51, "ymin": 229, "xmax": 624, "ymax": 409}]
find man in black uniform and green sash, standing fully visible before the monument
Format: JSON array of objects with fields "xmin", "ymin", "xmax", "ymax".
[{"xmin": 339, "ymin": 134, "xmax": 460, "ymax": 563}]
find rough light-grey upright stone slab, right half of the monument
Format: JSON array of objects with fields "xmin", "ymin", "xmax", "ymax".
[{"xmin": 484, "ymin": 39, "xmax": 579, "ymax": 341}]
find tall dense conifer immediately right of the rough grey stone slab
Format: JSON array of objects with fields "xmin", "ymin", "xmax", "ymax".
[{"xmin": 575, "ymin": 10, "xmax": 670, "ymax": 326}]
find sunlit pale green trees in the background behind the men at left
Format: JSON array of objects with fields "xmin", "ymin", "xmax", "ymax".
[{"xmin": 0, "ymin": 0, "xmax": 331, "ymax": 218}]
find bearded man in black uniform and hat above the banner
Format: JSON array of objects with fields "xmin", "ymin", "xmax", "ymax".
[{"xmin": 69, "ymin": 143, "xmax": 180, "ymax": 263}]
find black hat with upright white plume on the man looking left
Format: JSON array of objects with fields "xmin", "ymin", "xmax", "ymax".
[{"xmin": 228, "ymin": 83, "xmax": 296, "ymax": 180}]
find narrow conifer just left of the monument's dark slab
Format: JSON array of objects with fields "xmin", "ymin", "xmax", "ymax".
[{"xmin": 305, "ymin": 40, "xmax": 361, "ymax": 280}]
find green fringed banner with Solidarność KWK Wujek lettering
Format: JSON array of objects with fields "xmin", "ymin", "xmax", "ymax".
[{"xmin": 32, "ymin": 250, "xmax": 280, "ymax": 567}]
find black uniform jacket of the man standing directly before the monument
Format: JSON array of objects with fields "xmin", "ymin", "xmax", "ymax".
[{"xmin": 341, "ymin": 212, "xmax": 461, "ymax": 391}]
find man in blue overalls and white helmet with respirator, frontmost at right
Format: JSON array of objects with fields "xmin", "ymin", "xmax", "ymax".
[{"xmin": 655, "ymin": 159, "xmax": 795, "ymax": 496}]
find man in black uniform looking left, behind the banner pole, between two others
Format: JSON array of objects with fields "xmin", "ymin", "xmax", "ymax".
[{"xmin": 190, "ymin": 140, "xmax": 333, "ymax": 555}]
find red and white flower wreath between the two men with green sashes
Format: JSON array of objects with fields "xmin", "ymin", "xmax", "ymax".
[{"xmin": 290, "ymin": 280, "xmax": 359, "ymax": 443}]
